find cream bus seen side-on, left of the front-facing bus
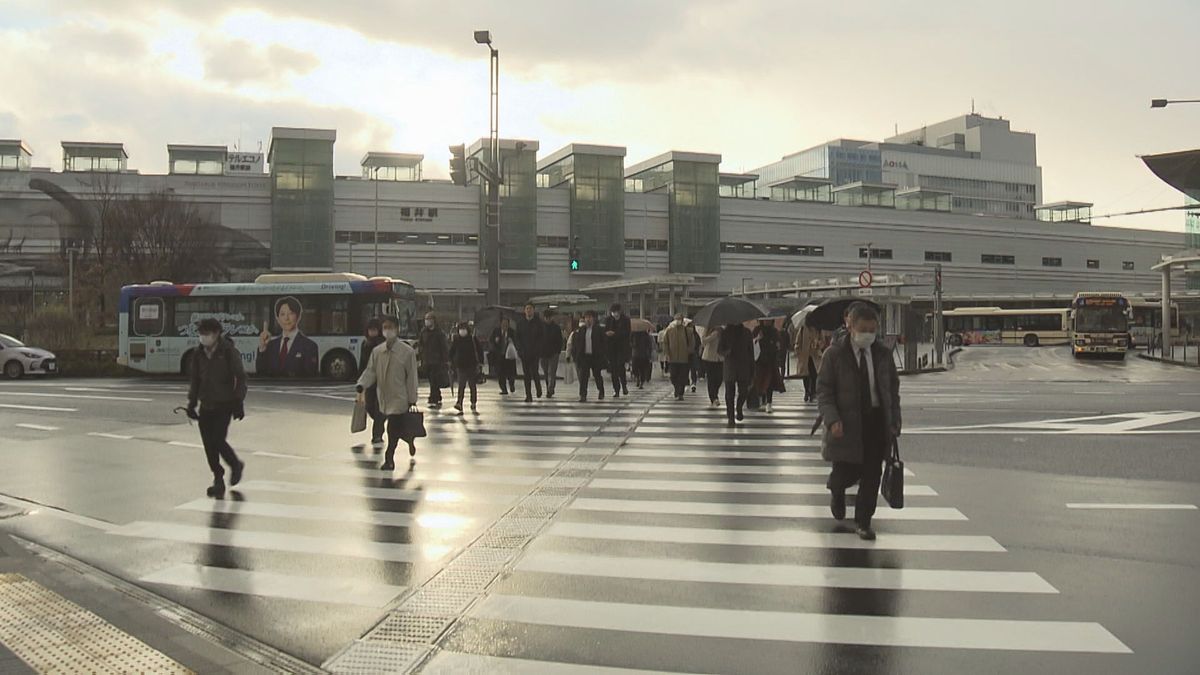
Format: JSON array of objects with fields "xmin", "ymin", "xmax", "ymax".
[{"xmin": 942, "ymin": 307, "xmax": 1070, "ymax": 347}]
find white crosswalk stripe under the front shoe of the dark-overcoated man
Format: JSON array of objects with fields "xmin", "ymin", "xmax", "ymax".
[{"xmin": 546, "ymin": 521, "xmax": 1007, "ymax": 552}]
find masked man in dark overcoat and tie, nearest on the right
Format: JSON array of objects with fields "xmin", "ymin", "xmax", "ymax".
[{"xmin": 817, "ymin": 303, "xmax": 900, "ymax": 540}]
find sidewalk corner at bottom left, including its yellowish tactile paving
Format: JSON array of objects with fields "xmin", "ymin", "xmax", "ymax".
[{"xmin": 0, "ymin": 528, "xmax": 271, "ymax": 674}]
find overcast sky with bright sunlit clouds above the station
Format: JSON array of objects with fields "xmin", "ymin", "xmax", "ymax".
[{"xmin": 0, "ymin": 0, "xmax": 1200, "ymax": 231}]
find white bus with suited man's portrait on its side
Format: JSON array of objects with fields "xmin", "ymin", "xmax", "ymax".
[{"xmin": 118, "ymin": 273, "xmax": 418, "ymax": 380}]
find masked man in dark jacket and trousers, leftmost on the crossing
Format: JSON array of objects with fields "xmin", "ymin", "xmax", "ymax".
[{"xmin": 187, "ymin": 318, "xmax": 246, "ymax": 498}]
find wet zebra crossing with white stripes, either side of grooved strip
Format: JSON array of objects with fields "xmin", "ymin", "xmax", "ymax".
[{"xmin": 77, "ymin": 372, "xmax": 1130, "ymax": 674}]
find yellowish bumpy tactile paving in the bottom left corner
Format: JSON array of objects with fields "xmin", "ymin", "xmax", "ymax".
[{"xmin": 0, "ymin": 574, "xmax": 191, "ymax": 673}]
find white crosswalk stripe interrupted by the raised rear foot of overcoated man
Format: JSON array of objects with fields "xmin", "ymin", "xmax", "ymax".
[{"xmin": 569, "ymin": 497, "xmax": 967, "ymax": 520}]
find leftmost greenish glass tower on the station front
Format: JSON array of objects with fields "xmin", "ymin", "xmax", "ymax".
[{"xmin": 270, "ymin": 130, "xmax": 334, "ymax": 270}]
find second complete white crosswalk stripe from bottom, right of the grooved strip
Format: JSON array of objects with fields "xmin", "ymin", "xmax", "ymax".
[{"xmin": 516, "ymin": 551, "xmax": 1058, "ymax": 593}]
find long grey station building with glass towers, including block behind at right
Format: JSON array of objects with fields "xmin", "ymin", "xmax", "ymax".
[{"xmin": 0, "ymin": 115, "xmax": 1182, "ymax": 312}]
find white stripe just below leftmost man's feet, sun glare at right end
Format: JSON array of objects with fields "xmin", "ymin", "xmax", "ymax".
[{"xmin": 175, "ymin": 498, "xmax": 476, "ymax": 536}]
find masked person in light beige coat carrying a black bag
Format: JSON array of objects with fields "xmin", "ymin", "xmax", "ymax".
[{"xmin": 358, "ymin": 317, "xmax": 418, "ymax": 471}]
